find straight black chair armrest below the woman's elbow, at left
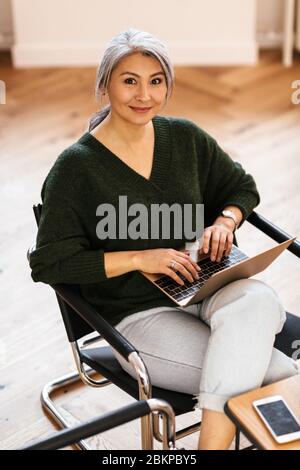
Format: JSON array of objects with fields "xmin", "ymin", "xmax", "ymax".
[{"xmin": 51, "ymin": 284, "xmax": 138, "ymax": 360}]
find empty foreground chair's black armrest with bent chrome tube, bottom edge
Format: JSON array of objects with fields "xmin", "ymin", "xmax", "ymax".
[{"xmin": 18, "ymin": 398, "xmax": 176, "ymax": 450}]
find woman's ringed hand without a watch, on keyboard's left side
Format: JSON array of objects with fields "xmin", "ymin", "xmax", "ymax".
[{"xmin": 134, "ymin": 248, "xmax": 200, "ymax": 285}]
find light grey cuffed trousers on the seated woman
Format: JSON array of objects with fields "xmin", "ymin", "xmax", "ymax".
[{"xmin": 114, "ymin": 279, "xmax": 299, "ymax": 411}]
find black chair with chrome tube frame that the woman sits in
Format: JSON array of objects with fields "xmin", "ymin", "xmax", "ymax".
[{"xmin": 28, "ymin": 204, "xmax": 300, "ymax": 449}]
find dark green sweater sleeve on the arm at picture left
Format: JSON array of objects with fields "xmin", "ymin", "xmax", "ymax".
[{"xmin": 29, "ymin": 158, "xmax": 107, "ymax": 284}]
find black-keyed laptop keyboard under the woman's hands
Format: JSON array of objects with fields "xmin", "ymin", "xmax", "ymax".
[{"xmin": 154, "ymin": 245, "xmax": 248, "ymax": 302}]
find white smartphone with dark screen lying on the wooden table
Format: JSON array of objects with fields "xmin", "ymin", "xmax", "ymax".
[{"xmin": 252, "ymin": 395, "xmax": 300, "ymax": 444}]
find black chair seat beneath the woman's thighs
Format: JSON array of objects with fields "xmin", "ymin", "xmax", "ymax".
[{"xmin": 80, "ymin": 346, "xmax": 196, "ymax": 415}]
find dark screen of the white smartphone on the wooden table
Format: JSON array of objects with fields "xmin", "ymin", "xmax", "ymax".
[{"xmin": 257, "ymin": 400, "xmax": 300, "ymax": 436}]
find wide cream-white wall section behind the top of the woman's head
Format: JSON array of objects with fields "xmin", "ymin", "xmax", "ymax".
[{"xmin": 12, "ymin": 0, "xmax": 257, "ymax": 67}]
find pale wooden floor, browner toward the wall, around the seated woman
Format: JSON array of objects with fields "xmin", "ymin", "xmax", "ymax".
[{"xmin": 0, "ymin": 51, "xmax": 300, "ymax": 449}]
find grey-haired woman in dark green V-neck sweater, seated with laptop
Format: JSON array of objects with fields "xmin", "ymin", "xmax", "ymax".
[{"xmin": 31, "ymin": 29, "xmax": 298, "ymax": 449}]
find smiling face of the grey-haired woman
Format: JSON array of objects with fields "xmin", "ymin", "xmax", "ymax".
[{"xmin": 108, "ymin": 52, "xmax": 167, "ymax": 124}]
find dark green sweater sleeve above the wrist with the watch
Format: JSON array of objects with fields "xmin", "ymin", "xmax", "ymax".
[{"xmin": 195, "ymin": 125, "xmax": 260, "ymax": 227}]
